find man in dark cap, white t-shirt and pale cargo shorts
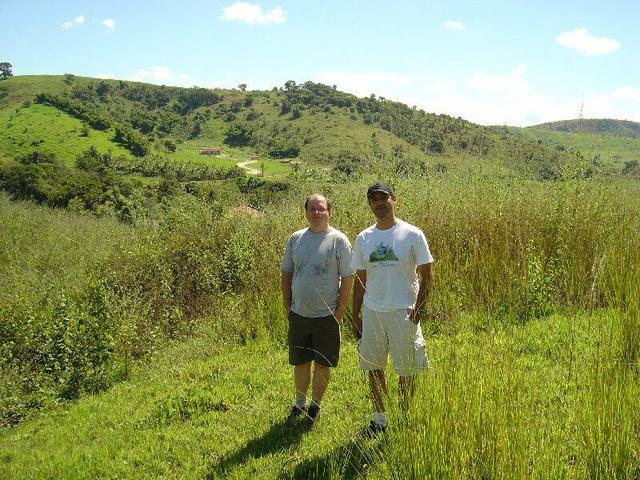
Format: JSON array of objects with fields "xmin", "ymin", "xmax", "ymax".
[{"xmin": 351, "ymin": 182, "xmax": 433, "ymax": 434}]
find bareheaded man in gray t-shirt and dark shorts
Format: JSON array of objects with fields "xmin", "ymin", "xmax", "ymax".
[{"xmin": 280, "ymin": 194, "xmax": 353, "ymax": 420}]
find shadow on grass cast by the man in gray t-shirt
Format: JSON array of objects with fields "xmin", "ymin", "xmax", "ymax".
[{"xmin": 206, "ymin": 418, "xmax": 312, "ymax": 479}]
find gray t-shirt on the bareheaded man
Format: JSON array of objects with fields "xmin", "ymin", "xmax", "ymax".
[{"xmin": 280, "ymin": 227, "xmax": 353, "ymax": 318}]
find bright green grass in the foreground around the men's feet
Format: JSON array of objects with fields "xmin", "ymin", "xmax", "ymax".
[{"xmin": 0, "ymin": 311, "xmax": 640, "ymax": 479}]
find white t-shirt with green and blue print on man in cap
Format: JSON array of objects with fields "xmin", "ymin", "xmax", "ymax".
[{"xmin": 351, "ymin": 220, "xmax": 433, "ymax": 312}]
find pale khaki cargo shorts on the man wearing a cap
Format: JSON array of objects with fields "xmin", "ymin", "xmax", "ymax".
[{"xmin": 358, "ymin": 306, "xmax": 429, "ymax": 377}]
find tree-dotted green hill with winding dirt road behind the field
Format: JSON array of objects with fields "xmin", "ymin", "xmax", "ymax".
[{"xmin": 0, "ymin": 74, "xmax": 640, "ymax": 219}]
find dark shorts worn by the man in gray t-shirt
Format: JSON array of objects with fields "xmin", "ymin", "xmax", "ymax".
[{"xmin": 289, "ymin": 311, "xmax": 340, "ymax": 367}]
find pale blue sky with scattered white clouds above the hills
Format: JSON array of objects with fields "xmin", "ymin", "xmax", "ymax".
[{"xmin": 0, "ymin": 0, "xmax": 640, "ymax": 126}]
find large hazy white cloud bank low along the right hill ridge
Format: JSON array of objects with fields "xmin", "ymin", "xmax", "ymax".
[{"xmin": 313, "ymin": 63, "xmax": 640, "ymax": 126}]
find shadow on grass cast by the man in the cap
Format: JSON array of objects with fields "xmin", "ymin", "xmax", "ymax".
[{"xmin": 288, "ymin": 429, "xmax": 382, "ymax": 480}]
